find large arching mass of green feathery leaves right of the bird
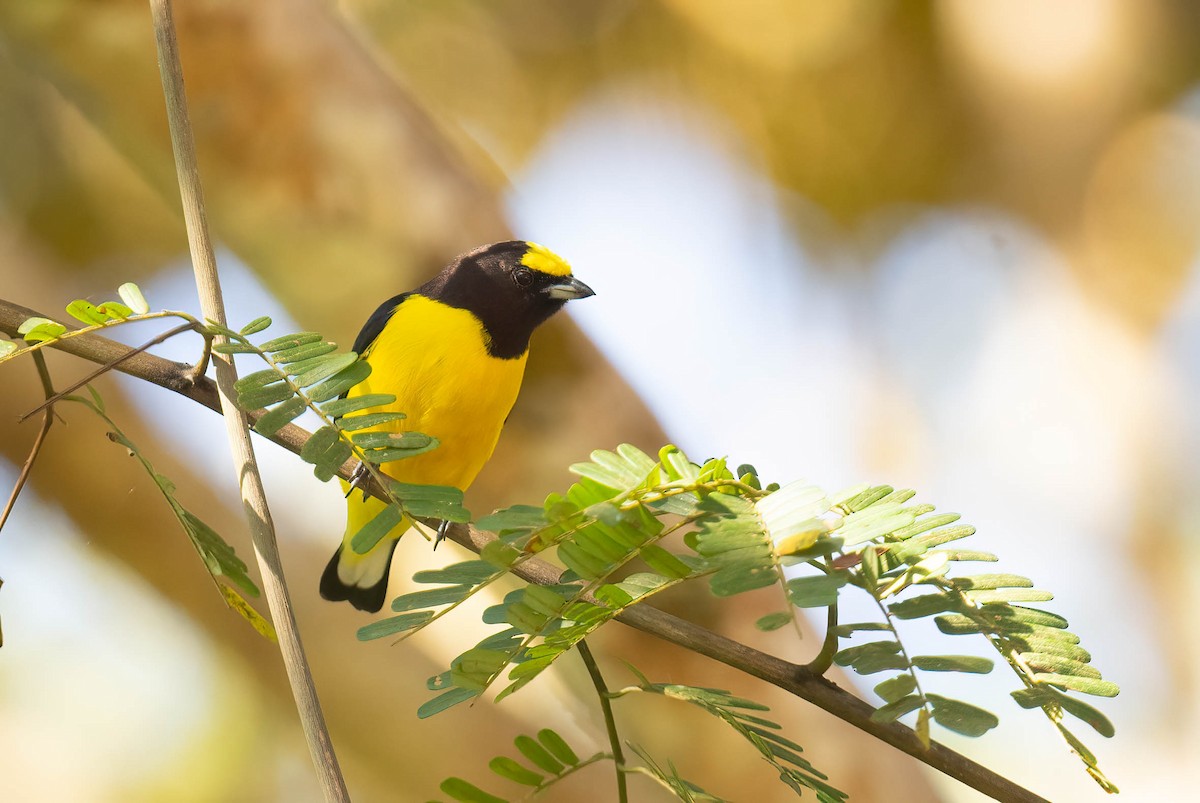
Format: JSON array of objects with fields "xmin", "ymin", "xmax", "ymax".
[{"xmin": 376, "ymin": 444, "xmax": 1117, "ymax": 789}]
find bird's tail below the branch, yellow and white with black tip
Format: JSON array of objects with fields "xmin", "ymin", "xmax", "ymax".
[{"xmin": 320, "ymin": 489, "xmax": 410, "ymax": 613}]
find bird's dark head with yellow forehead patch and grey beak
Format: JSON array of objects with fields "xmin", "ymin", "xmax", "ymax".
[{"xmin": 418, "ymin": 240, "xmax": 594, "ymax": 358}]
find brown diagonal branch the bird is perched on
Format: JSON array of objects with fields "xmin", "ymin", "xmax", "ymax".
[{"xmin": 0, "ymin": 299, "xmax": 1046, "ymax": 803}]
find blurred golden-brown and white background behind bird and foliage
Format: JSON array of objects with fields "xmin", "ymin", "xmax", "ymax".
[{"xmin": 0, "ymin": 0, "xmax": 1200, "ymax": 802}]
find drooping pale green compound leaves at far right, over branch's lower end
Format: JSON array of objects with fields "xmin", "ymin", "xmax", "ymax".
[{"xmin": 780, "ymin": 486, "xmax": 1118, "ymax": 791}]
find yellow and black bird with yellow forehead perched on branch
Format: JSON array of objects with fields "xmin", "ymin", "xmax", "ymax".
[{"xmin": 320, "ymin": 240, "xmax": 594, "ymax": 612}]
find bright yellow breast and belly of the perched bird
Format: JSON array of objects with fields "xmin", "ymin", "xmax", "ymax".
[{"xmin": 349, "ymin": 295, "xmax": 527, "ymax": 490}]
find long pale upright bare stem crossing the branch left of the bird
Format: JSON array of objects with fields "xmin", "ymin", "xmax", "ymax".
[{"xmin": 150, "ymin": 0, "xmax": 350, "ymax": 802}]
